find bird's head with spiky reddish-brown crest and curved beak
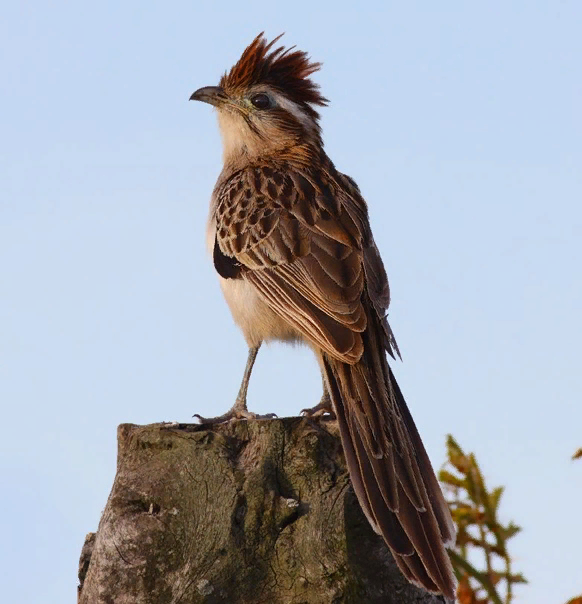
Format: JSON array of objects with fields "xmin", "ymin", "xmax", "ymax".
[{"xmin": 190, "ymin": 33, "xmax": 327, "ymax": 161}]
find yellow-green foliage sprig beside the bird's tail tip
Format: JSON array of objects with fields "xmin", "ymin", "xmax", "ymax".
[{"xmin": 439, "ymin": 435, "xmax": 527, "ymax": 604}]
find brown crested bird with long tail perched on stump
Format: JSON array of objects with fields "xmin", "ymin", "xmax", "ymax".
[{"xmin": 190, "ymin": 33, "xmax": 456, "ymax": 599}]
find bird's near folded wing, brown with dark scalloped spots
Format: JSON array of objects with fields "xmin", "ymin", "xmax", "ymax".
[{"xmin": 215, "ymin": 166, "xmax": 366, "ymax": 363}]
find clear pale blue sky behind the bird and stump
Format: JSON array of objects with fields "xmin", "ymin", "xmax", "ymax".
[{"xmin": 0, "ymin": 0, "xmax": 582, "ymax": 604}]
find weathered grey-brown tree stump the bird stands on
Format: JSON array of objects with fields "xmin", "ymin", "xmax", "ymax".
[{"xmin": 79, "ymin": 418, "xmax": 444, "ymax": 604}]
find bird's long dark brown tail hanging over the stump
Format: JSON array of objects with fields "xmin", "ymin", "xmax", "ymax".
[{"xmin": 322, "ymin": 302, "xmax": 456, "ymax": 599}]
